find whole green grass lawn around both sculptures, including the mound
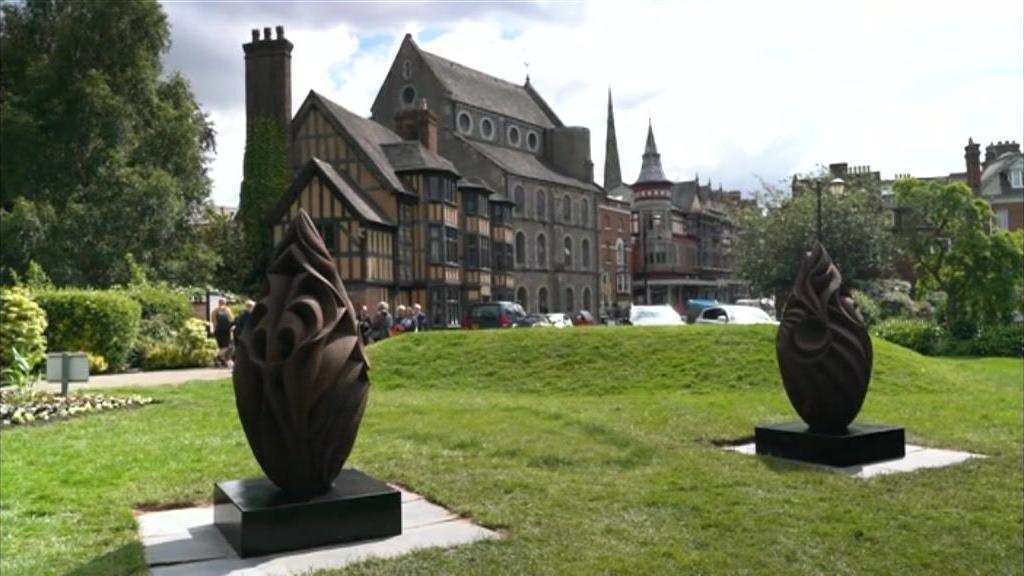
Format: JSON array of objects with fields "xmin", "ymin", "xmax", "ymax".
[{"xmin": 0, "ymin": 326, "xmax": 1024, "ymax": 576}]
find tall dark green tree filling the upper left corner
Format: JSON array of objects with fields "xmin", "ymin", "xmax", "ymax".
[{"xmin": 0, "ymin": 0, "xmax": 214, "ymax": 286}]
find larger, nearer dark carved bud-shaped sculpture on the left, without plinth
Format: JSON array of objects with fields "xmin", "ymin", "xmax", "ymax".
[{"xmin": 233, "ymin": 211, "xmax": 370, "ymax": 494}]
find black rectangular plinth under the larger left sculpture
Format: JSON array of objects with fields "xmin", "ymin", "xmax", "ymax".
[{"xmin": 213, "ymin": 469, "xmax": 401, "ymax": 558}]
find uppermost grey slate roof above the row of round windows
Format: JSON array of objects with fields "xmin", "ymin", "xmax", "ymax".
[{"xmin": 417, "ymin": 47, "xmax": 562, "ymax": 128}]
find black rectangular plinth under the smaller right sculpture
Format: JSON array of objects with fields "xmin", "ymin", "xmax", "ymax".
[{"xmin": 754, "ymin": 422, "xmax": 906, "ymax": 466}]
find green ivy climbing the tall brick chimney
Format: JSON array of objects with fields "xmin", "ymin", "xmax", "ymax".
[{"xmin": 236, "ymin": 118, "xmax": 291, "ymax": 290}]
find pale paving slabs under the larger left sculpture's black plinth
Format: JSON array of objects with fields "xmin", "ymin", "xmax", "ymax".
[{"xmin": 137, "ymin": 481, "xmax": 500, "ymax": 576}]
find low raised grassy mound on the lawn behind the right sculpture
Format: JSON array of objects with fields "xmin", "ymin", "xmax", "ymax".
[{"xmin": 370, "ymin": 326, "xmax": 955, "ymax": 395}]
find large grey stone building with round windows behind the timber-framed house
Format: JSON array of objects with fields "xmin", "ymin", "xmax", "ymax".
[{"xmin": 372, "ymin": 35, "xmax": 604, "ymax": 313}]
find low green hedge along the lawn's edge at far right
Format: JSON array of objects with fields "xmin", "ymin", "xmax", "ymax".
[{"xmin": 871, "ymin": 318, "xmax": 1024, "ymax": 358}]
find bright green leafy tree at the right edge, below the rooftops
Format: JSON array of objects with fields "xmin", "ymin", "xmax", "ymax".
[{"xmin": 895, "ymin": 179, "xmax": 1024, "ymax": 325}]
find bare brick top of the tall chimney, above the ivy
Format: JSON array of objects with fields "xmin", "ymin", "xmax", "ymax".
[{"xmin": 242, "ymin": 26, "xmax": 292, "ymax": 150}]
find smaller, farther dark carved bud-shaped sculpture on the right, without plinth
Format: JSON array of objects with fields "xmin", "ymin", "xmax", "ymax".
[{"xmin": 776, "ymin": 244, "xmax": 872, "ymax": 431}]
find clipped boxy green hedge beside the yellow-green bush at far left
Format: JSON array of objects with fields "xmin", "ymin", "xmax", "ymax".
[{"xmin": 37, "ymin": 289, "xmax": 142, "ymax": 370}]
